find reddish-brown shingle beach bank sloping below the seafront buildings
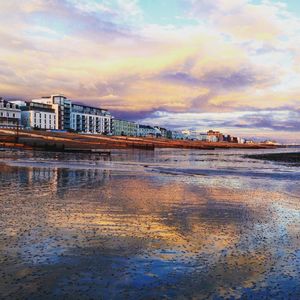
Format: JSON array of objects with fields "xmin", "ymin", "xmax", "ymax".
[{"xmin": 0, "ymin": 129, "xmax": 279, "ymax": 153}]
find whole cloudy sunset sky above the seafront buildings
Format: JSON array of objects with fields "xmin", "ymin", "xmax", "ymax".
[{"xmin": 0, "ymin": 0, "xmax": 300, "ymax": 142}]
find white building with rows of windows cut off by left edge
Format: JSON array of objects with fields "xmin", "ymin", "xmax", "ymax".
[{"xmin": 0, "ymin": 98, "xmax": 21, "ymax": 128}]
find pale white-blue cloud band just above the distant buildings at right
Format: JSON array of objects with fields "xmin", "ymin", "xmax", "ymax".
[{"xmin": 137, "ymin": 110, "xmax": 300, "ymax": 142}]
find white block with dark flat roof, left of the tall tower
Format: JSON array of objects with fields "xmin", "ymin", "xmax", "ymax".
[{"xmin": 18, "ymin": 101, "xmax": 58, "ymax": 130}]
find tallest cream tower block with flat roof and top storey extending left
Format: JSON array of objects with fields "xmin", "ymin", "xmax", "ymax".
[{"xmin": 32, "ymin": 94, "xmax": 71, "ymax": 130}]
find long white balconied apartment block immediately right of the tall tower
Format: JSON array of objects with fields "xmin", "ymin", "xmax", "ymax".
[{"xmin": 70, "ymin": 103, "xmax": 112, "ymax": 134}]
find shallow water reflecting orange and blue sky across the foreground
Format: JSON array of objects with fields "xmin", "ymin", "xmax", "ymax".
[{"xmin": 0, "ymin": 149, "xmax": 300, "ymax": 299}]
